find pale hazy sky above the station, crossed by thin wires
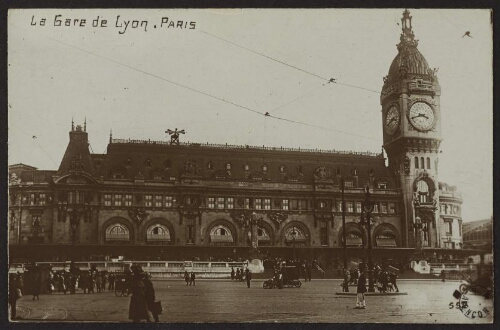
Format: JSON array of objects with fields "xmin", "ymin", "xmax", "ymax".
[{"xmin": 8, "ymin": 9, "xmax": 493, "ymax": 221}]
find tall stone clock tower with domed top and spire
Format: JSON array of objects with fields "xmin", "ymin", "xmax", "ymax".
[{"xmin": 380, "ymin": 10, "xmax": 442, "ymax": 249}]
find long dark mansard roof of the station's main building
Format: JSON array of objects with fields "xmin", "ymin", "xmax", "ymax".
[{"xmin": 92, "ymin": 139, "xmax": 396, "ymax": 189}]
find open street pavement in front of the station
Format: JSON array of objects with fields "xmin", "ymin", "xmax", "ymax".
[{"xmin": 9, "ymin": 280, "xmax": 493, "ymax": 324}]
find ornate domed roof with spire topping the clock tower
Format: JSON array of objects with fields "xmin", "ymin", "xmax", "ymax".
[{"xmin": 387, "ymin": 9, "xmax": 431, "ymax": 81}]
